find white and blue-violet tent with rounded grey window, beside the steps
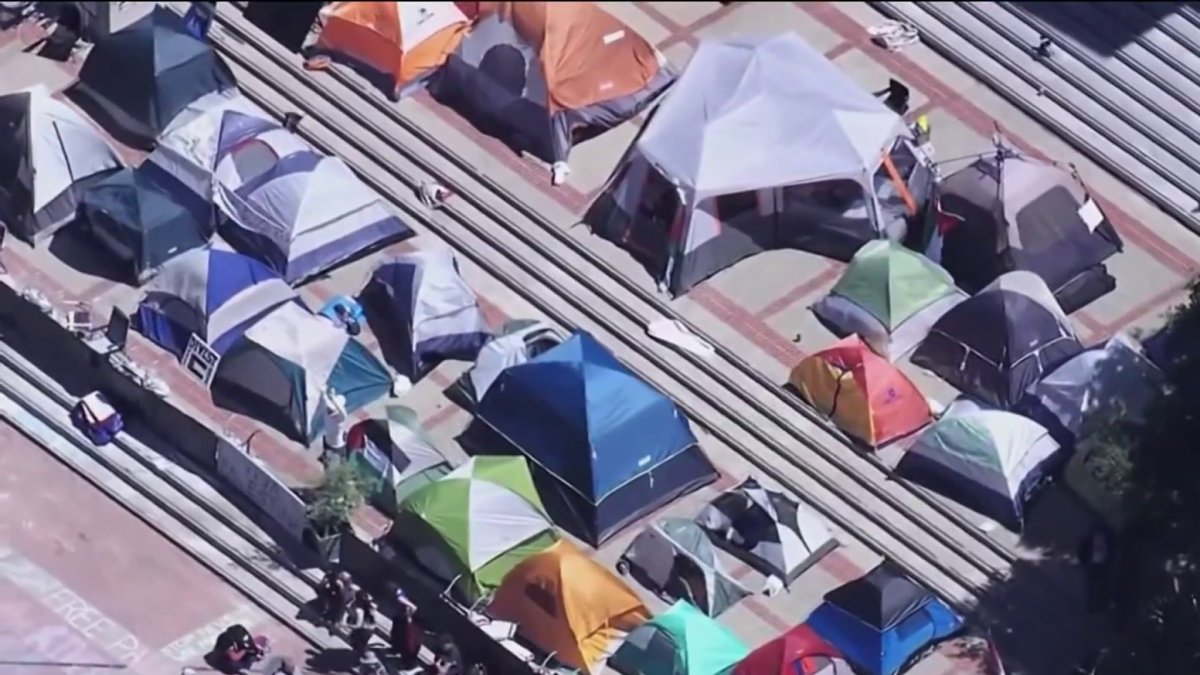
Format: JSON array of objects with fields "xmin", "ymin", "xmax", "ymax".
[{"xmin": 214, "ymin": 112, "xmax": 412, "ymax": 283}]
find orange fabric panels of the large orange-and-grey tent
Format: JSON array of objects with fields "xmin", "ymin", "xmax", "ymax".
[{"xmin": 478, "ymin": 2, "xmax": 662, "ymax": 113}]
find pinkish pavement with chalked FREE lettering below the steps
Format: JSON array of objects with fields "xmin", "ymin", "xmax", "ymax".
[{"xmin": 0, "ymin": 424, "xmax": 307, "ymax": 675}]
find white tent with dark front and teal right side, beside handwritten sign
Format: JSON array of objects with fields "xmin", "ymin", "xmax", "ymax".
[{"xmin": 211, "ymin": 303, "xmax": 392, "ymax": 443}]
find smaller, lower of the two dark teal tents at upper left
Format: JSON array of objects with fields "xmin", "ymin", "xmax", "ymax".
[{"xmin": 79, "ymin": 168, "xmax": 212, "ymax": 281}]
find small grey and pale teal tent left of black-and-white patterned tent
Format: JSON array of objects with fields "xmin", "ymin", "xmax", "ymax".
[{"xmin": 617, "ymin": 518, "xmax": 751, "ymax": 616}]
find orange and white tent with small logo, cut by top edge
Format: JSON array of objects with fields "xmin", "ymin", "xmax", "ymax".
[{"xmin": 317, "ymin": 2, "xmax": 469, "ymax": 88}]
